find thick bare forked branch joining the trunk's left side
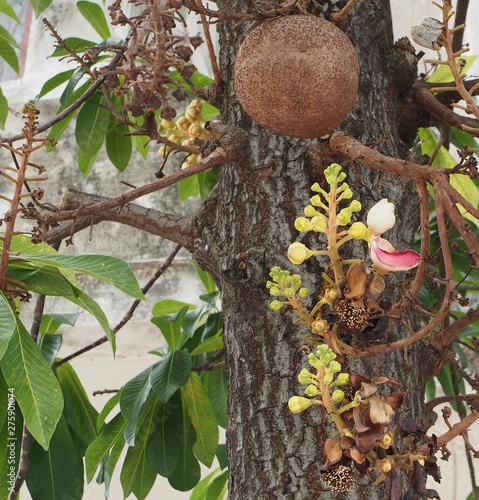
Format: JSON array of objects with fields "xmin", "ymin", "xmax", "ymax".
[{"xmin": 45, "ymin": 189, "xmax": 194, "ymax": 252}]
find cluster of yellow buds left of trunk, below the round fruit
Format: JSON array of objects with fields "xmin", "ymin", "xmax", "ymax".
[{"xmin": 158, "ymin": 99, "xmax": 213, "ymax": 168}]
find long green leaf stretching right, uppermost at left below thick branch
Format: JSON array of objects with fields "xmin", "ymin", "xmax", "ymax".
[{"xmin": 11, "ymin": 255, "xmax": 145, "ymax": 300}]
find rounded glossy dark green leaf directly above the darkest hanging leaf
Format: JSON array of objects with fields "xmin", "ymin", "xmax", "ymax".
[{"xmin": 150, "ymin": 351, "xmax": 191, "ymax": 403}]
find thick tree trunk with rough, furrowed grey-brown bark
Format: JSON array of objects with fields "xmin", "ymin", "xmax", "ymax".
[{"xmin": 196, "ymin": 0, "xmax": 442, "ymax": 500}]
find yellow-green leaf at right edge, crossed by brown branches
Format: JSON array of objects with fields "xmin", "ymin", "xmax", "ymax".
[{"xmin": 418, "ymin": 128, "xmax": 479, "ymax": 226}]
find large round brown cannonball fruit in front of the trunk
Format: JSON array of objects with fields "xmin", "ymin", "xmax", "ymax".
[{"xmin": 235, "ymin": 15, "xmax": 359, "ymax": 139}]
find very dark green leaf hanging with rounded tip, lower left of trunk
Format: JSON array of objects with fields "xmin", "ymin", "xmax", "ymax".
[{"xmin": 168, "ymin": 397, "xmax": 201, "ymax": 491}]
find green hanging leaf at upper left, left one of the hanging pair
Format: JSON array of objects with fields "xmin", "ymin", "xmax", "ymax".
[{"xmin": 75, "ymin": 94, "xmax": 110, "ymax": 177}]
